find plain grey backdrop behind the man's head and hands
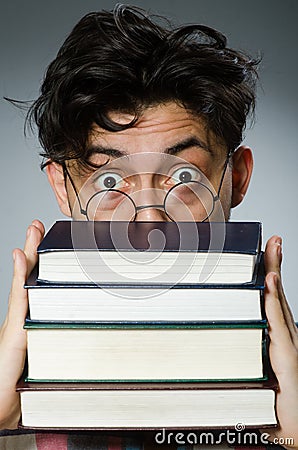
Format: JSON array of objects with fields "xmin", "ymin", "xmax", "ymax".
[{"xmin": 0, "ymin": 0, "xmax": 298, "ymax": 322}]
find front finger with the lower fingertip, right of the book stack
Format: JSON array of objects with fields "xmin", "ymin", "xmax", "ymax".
[{"xmin": 265, "ymin": 272, "xmax": 297, "ymax": 376}]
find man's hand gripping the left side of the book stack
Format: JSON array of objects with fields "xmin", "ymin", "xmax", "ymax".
[{"xmin": 0, "ymin": 220, "xmax": 44, "ymax": 429}]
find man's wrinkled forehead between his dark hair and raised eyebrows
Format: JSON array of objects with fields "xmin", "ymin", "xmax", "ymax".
[{"xmin": 88, "ymin": 102, "xmax": 227, "ymax": 158}]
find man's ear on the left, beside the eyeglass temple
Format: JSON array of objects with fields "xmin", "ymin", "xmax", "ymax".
[{"xmin": 46, "ymin": 161, "xmax": 71, "ymax": 217}]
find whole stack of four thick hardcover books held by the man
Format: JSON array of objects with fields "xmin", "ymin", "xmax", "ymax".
[{"xmin": 17, "ymin": 221, "xmax": 276, "ymax": 430}]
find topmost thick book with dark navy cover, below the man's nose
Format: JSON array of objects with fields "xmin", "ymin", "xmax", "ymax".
[{"xmin": 38, "ymin": 221, "xmax": 261, "ymax": 285}]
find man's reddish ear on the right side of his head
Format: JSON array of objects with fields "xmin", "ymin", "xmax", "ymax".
[{"xmin": 231, "ymin": 145, "xmax": 253, "ymax": 208}]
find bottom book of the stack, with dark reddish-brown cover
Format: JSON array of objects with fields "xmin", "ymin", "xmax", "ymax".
[{"xmin": 17, "ymin": 380, "xmax": 277, "ymax": 431}]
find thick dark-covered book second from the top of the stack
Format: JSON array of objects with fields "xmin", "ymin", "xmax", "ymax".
[{"xmin": 25, "ymin": 260, "xmax": 265, "ymax": 322}]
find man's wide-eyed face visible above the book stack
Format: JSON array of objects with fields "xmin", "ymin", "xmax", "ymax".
[{"xmin": 66, "ymin": 103, "xmax": 232, "ymax": 221}]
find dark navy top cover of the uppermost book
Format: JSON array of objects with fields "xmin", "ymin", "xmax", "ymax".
[{"xmin": 38, "ymin": 220, "xmax": 261, "ymax": 254}]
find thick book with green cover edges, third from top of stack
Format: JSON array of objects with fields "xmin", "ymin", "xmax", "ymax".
[{"xmin": 25, "ymin": 320, "xmax": 267, "ymax": 382}]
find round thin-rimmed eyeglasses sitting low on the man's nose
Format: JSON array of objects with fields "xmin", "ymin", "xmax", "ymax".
[{"xmin": 63, "ymin": 153, "xmax": 232, "ymax": 222}]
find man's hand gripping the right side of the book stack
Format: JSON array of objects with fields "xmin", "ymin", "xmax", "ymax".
[{"xmin": 262, "ymin": 236, "xmax": 298, "ymax": 449}]
